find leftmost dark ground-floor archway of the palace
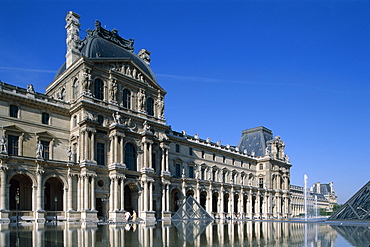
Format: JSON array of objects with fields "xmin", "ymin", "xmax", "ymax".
[{"xmin": 9, "ymin": 174, "xmax": 32, "ymax": 210}]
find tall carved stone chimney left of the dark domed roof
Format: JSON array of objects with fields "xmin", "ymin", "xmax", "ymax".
[{"xmin": 65, "ymin": 11, "xmax": 81, "ymax": 69}]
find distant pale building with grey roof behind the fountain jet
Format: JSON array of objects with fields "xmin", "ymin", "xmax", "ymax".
[{"xmin": 290, "ymin": 182, "xmax": 337, "ymax": 216}]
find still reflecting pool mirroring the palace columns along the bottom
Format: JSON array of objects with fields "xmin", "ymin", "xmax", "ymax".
[{"xmin": 0, "ymin": 220, "xmax": 370, "ymax": 247}]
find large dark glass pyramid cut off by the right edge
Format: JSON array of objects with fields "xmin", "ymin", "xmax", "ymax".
[{"xmin": 328, "ymin": 181, "xmax": 370, "ymax": 221}]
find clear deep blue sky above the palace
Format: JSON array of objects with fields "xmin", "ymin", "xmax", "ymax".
[{"xmin": 0, "ymin": 0, "xmax": 370, "ymax": 203}]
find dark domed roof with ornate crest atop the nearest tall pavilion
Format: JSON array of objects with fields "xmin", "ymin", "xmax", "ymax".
[{"xmin": 55, "ymin": 21, "xmax": 156, "ymax": 81}]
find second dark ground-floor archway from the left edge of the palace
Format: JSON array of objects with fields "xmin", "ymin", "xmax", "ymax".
[{"xmin": 44, "ymin": 177, "xmax": 63, "ymax": 211}]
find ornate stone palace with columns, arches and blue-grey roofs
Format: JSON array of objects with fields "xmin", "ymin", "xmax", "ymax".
[{"xmin": 0, "ymin": 12, "xmax": 291, "ymax": 223}]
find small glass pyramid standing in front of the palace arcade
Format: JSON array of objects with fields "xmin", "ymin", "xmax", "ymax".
[{"xmin": 172, "ymin": 196, "xmax": 213, "ymax": 220}]
